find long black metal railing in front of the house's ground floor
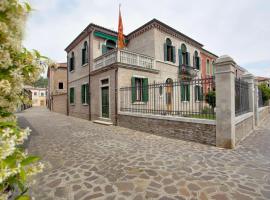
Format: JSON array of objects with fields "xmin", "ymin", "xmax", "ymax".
[{"xmin": 120, "ymin": 77, "xmax": 216, "ymax": 119}]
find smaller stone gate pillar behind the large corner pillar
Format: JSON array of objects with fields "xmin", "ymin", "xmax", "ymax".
[{"xmin": 242, "ymin": 73, "xmax": 255, "ymax": 128}]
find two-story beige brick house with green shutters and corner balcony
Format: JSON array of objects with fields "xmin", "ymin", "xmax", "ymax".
[{"xmin": 65, "ymin": 19, "xmax": 217, "ymax": 124}]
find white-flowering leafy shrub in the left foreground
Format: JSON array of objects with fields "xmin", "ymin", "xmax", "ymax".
[{"xmin": 0, "ymin": 0, "xmax": 47, "ymax": 200}]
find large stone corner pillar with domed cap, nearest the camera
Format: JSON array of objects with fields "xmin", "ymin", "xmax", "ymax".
[{"xmin": 215, "ymin": 56, "xmax": 236, "ymax": 148}]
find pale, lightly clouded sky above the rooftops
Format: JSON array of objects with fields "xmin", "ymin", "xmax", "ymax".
[{"xmin": 24, "ymin": 0, "xmax": 270, "ymax": 77}]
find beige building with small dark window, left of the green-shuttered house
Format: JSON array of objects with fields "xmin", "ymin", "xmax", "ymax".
[{"xmin": 47, "ymin": 63, "xmax": 67, "ymax": 114}]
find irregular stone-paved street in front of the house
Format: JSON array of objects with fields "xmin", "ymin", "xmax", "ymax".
[{"xmin": 18, "ymin": 108, "xmax": 270, "ymax": 200}]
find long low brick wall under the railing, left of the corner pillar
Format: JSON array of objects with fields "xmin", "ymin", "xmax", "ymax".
[{"xmin": 118, "ymin": 114, "xmax": 216, "ymax": 145}]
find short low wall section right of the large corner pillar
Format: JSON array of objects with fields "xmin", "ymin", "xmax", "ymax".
[{"xmin": 235, "ymin": 113, "xmax": 254, "ymax": 144}]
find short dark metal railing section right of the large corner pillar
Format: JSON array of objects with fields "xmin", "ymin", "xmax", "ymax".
[{"xmin": 235, "ymin": 78, "xmax": 250, "ymax": 116}]
